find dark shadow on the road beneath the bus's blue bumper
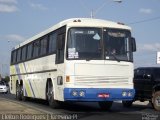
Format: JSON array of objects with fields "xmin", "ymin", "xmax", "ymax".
[{"xmin": 59, "ymin": 102, "xmax": 154, "ymax": 113}]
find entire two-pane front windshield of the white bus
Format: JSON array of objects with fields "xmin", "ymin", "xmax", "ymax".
[{"xmin": 67, "ymin": 28, "xmax": 133, "ymax": 61}]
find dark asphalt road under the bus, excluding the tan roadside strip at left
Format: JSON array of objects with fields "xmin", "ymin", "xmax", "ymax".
[{"xmin": 0, "ymin": 94, "xmax": 160, "ymax": 120}]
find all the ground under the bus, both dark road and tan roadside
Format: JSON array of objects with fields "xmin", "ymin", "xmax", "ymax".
[{"xmin": 0, "ymin": 94, "xmax": 160, "ymax": 120}]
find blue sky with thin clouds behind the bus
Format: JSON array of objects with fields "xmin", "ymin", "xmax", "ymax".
[{"xmin": 0, "ymin": 0, "xmax": 160, "ymax": 76}]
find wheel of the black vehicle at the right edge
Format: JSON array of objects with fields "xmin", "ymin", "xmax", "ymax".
[{"xmin": 152, "ymin": 91, "xmax": 160, "ymax": 111}]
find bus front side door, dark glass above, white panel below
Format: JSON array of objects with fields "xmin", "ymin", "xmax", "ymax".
[{"xmin": 54, "ymin": 32, "xmax": 65, "ymax": 100}]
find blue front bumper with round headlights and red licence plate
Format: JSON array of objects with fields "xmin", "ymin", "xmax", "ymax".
[{"xmin": 64, "ymin": 88, "xmax": 135, "ymax": 102}]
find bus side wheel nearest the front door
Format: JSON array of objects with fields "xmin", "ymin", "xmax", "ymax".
[{"xmin": 47, "ymin": 82, "xmax": 60, "ymax": 109}]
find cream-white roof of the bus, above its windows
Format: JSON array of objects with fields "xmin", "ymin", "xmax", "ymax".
[{"xmin": 13, "ymin": 18, "xmax": 131, "ymax": 50}]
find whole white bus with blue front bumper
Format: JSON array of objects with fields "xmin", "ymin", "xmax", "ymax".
[{"xmin": 10, "ymin": 18, "xmax": 136, "ymax": 109}]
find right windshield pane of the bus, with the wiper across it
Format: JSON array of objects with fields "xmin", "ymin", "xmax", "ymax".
[{"xmin": 103, "ymin": 29, "xmax": 133, "ymax": 61}]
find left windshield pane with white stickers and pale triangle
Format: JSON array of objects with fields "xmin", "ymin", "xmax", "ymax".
[{"xmin": 67, "ymin": 28, "xmax": 102, "ymax": 60}]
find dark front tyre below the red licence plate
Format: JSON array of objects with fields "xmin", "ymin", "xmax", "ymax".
[{"xmin": 98, "ymin": 101, "xmax": 113, "ymax": 110}]
